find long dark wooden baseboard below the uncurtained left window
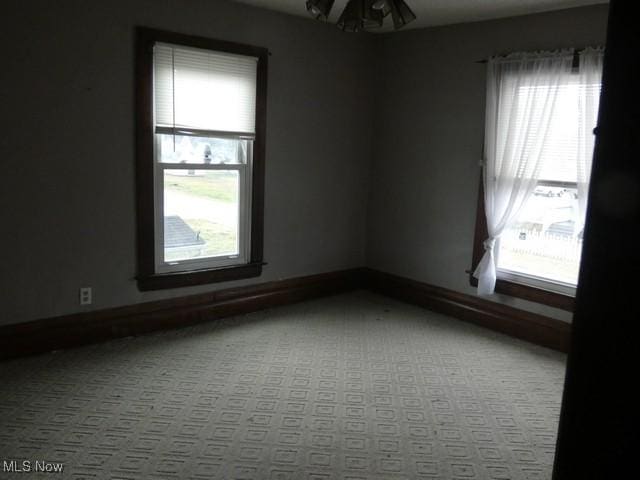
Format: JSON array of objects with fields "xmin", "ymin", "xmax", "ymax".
[{"xmin": 0, "ymin": 269, "xmax": 363, "ymax": 359}]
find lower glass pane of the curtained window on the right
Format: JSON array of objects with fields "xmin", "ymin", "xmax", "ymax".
[{"xmin": 498, "ymin": 185, "xmax": 582, "ymax": 286}]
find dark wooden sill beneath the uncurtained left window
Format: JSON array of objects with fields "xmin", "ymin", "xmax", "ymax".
[{"xmin": 136, "ymin": 262, "xmax": 264, "ymax": 292}]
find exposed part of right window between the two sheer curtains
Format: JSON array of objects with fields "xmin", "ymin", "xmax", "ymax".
[{"xmin": 497, "ymin": 79, "xmax": 600, "ymax": 295}]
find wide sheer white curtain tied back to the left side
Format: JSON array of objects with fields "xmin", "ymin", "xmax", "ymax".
[{"xmin": 474, "ymin": 50, "xmax": 573, "ymax": 295}]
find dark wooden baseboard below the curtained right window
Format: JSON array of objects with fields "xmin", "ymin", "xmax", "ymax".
[{"xmin": 364, "ymin": 269, "xmax": 571, "ymax": 352}]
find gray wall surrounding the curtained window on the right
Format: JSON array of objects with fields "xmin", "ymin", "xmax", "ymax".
[{"xmin": 367, "ymin": 5, "xmax": 608, "ymax": 320}]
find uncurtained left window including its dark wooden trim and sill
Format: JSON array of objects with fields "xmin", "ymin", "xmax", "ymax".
[{"xmin": 137, "ymin": 28, "xmax": 268, "ymax": 290}]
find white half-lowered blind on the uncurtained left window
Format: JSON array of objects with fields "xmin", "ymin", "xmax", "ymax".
[{"xmin": 154, "ymin": 43, "xmax": 258, "ymax": 136}]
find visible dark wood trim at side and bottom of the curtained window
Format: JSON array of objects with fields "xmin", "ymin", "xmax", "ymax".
[{"xmin": 469, "ymin": 172, "xmax": 574, "ymax": 312}]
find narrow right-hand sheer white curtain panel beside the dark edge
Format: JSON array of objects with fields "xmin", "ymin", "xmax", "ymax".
[{"xmin": 576, "ymin": 48, "xmax": 604, "ymax": 232}]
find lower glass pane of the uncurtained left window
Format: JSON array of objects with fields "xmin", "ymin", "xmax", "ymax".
[{"xmin": 164, "ymin": 170, "xmax": 240, "ymax": 262}]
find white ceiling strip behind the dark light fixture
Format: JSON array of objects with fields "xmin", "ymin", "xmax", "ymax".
[{"xmin": 236, "ymin": 0, "xmax": 609, "ymax": 31}]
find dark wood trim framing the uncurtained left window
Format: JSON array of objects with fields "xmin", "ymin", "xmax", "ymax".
[{"xmin": 135, "ymin": 27, "xmax": 269, "ymax": 290}]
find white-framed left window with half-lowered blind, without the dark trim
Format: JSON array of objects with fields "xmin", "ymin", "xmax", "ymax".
[{"xmin": 153, "ymin": 43, "xmax": 258, "ymax": 272}]
